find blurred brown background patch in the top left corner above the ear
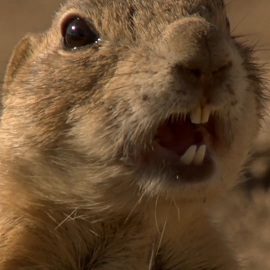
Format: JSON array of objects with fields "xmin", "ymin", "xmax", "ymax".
[{"xmin": 0, "ymin": 0, "xmax": 64, "ymax": 81}]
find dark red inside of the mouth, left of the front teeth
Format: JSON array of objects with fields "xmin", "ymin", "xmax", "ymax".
[{"xmin": 156, "ymin": 119, "xmax": 202, "ymax": 156}]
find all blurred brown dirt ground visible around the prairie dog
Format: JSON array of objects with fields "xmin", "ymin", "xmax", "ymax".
[{"xmin": 0, "ymin": 0, "xmax": 270, "ymax": 270}]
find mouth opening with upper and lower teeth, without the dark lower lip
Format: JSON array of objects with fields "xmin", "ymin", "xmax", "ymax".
[{"xmin": 155, "ymin": 106, "xmax": 217, "ymax": 165}]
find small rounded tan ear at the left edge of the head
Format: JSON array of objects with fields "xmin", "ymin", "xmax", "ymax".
[{"xmin": 4, "ymin": 34, "xmax": 36, "ymax": 86}]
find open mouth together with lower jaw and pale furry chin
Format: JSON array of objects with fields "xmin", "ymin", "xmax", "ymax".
[{"xmin": 122, "ymin": 104, "xmax": 253, "ymax": 204}]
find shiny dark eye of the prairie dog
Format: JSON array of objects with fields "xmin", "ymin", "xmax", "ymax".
[{"xmin": 62, "ymin": 17, "xmax": 99, "ymax": 49}]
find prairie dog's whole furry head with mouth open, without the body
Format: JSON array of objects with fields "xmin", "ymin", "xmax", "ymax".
[{"xmin": 0, "ymin": 0, "xmax": 263, "ymax": 211}]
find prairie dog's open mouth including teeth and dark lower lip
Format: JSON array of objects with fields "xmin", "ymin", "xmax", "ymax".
[{"xmin": 139, "ymin": 106, "xmax": 222, "ymax": 182}]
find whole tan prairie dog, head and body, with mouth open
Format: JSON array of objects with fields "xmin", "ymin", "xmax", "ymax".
[{"xmin": 0, "ymin": 0, "xmax": 264, "ymax": 270}]
